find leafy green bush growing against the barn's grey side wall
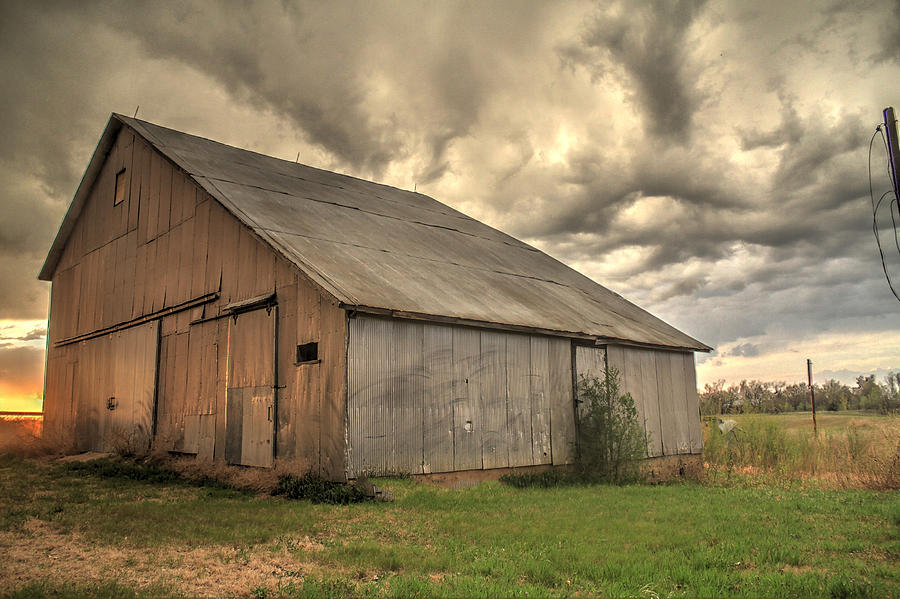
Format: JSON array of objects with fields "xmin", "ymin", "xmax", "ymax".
[{"xmin": 575, "ymin": 368, "xmax": 647, "ymax": 484}]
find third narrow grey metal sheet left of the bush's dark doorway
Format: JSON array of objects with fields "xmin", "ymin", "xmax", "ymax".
[{"xmin": 506, "ymin": 335, "xmax": 532, "ymax": 467}]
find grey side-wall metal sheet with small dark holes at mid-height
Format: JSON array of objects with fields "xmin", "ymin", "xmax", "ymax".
[{"xmin": 452, "ymin": 327, "xmax": 484, "ymax": 470}]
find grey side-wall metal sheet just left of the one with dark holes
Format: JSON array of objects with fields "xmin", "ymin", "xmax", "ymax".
[{"xmin": 422, "ymin": 324, "xmax": 453, "ymax": 474}]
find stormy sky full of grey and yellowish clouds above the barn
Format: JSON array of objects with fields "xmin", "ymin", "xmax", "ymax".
[{"xmin": 0, "ymin": 0, "xmax": 900, "ymax": 409}]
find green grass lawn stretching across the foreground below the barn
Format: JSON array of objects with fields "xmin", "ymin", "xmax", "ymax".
[{"xmin": 0, "ymin": 457, "xmax": 900, "ymax": 597}]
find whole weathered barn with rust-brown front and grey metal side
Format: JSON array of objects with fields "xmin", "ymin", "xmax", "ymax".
[{"xmin": 39, "ymin": 114, "xmax": 710, "ymax": 480}]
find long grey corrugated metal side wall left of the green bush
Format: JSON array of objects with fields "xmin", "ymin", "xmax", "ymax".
[{"xmin": 347, "ymin": 316, "xmax": 575, "ymax": 476}]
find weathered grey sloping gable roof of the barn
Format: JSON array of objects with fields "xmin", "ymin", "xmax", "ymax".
[{"xmin": 39, "ymin": 114, "xmax": 711, "ymax": 351}]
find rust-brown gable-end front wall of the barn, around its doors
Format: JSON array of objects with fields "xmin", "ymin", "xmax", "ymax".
[{"xmin": 45, "ymin": 127, "xmax": 346, "ymax": 476}]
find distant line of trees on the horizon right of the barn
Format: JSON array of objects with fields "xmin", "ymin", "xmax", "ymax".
[{"xmin": 699, "ymin": 372, "xmax": 900, "ymax": 415}]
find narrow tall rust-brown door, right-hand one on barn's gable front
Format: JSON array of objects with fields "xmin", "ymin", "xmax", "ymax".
[{"xmin": 225, "ymin": 306, "xmax": 275, "ymax": 467}]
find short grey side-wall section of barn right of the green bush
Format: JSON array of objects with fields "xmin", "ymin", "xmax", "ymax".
[{"xmin": 607, "ymin": 345, "xmax": 703, "ymax": 457}]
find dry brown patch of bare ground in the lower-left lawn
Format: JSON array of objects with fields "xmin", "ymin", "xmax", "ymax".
[{"xmin": 0, "ymin": 519, "xmax": 324, "ymax": 597}]
